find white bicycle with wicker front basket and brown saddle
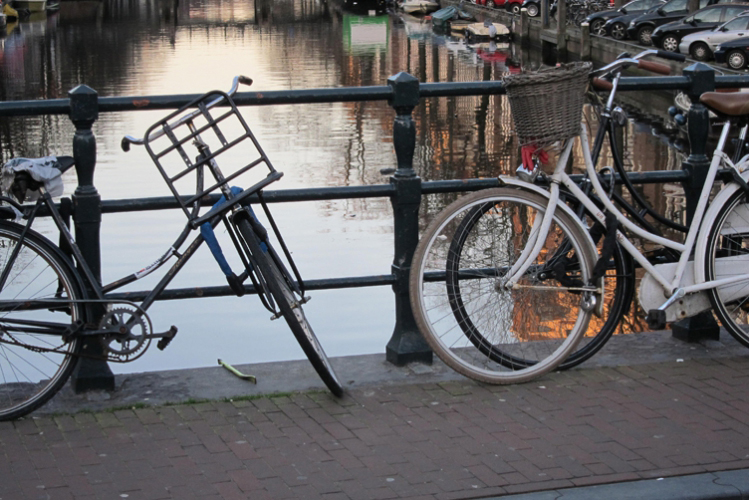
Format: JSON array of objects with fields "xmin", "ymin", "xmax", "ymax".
[{"xmin": 410, "ymin": 62, "xmax": 749, "ymax": 384}]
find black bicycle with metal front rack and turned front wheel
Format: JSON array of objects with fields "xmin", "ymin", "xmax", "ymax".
[{"xmin": 0, "ymin": 77, "xmax": 343, "ymax": 420}]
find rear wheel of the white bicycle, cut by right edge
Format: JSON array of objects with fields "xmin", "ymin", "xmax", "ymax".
[{"xmin": 704, "ymin": 190, "xmax": 749, "ymax": 347}]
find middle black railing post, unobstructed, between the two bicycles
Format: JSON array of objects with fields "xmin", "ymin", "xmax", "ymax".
[{"xmin": 385, "ymin": 72, "xmax": 432, "ymax": 366}]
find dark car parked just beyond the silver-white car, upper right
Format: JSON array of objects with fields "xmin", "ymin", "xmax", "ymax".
[{"xmin": 650, "ymin": 4, "xmax": 749, "ymax": 52}]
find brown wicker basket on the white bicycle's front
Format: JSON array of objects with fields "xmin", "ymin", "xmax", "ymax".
[{"xmin": 504, "ymin": 62, "xmax": 592, "ymax": 148}]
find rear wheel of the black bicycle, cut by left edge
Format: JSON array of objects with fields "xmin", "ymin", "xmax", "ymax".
[{"xmin": 0, "ymin": 222, "xmax": 85, "ymax": 420}]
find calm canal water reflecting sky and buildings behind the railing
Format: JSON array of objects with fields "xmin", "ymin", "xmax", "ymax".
[{"xmin": 0, "ymin": 0, "xmax": 683, "ymax": 379}]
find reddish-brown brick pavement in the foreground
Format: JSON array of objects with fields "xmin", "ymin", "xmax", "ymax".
[{"xmin": 0, "ymin": 355, "xmax": 749, "ymax": 500}]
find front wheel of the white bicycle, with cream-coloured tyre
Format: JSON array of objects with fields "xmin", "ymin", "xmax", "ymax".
[{"xmin": 410, "ymin": 188, "xmax": 596, "ymax": 384}]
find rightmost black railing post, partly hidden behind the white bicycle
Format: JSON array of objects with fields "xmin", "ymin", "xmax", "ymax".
[{"xmin": 671, "ymin": 63, "xmax": 720, "ymax": 342}]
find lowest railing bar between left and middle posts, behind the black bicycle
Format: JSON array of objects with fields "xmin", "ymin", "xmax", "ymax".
[{"xmin": 106, "ymin": 274, "xmax": 396, "ymax": 302}]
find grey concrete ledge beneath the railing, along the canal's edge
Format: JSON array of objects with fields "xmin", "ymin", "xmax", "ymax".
[{"xmin": 34, "ymin": 331, "xmax": 749, "ymax": 415}]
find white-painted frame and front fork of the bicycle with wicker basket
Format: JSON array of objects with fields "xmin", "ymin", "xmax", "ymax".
[{"xmin": 506, "ymin": 121, "xmax": 749, "ymax": 310}]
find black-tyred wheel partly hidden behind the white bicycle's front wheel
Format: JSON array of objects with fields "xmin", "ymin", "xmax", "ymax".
[{"xmin": 446, "ymin": 195, "xmax": 634, "ymax": 370}]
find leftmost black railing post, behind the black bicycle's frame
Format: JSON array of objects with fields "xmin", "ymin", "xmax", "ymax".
[{"xmin": 68, "ymin": 85, "xmax": 114, "ymax": 392}]
